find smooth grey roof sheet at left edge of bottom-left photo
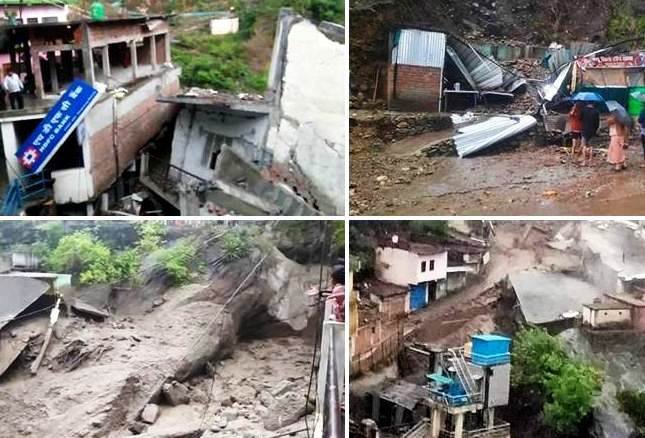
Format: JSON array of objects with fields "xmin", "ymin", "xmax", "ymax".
[{"xmin": 0, "ymin": 277, "xmax": 49, "ymax": 329}]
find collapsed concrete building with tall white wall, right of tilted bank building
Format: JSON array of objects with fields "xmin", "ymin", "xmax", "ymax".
[{"xmin": 142, "ymin": 9, "xmax": 346, "ymax": 215}]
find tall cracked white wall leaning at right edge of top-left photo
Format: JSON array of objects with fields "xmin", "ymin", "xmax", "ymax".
[{"xmin": 267, "ymin": 11, "xmax": 347, "ymax": 214}]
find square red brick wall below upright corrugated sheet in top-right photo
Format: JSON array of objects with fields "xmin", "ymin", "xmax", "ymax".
[{"xmin": 391, "ymin": 64, "xmax": 441, "ymax": 112}]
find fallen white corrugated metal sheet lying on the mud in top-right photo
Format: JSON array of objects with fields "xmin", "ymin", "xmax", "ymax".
[{"xmin": 453, "ymin": 116, "xmax": 537, "ymax": 158}]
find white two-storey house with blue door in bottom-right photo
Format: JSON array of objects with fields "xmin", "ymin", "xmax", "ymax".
[{"xmin": 375, "ymin": 235, "xmax": 448, "ymax": 313}]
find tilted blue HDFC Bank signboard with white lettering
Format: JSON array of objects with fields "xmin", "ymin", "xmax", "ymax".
[{"xmin": 16, "ymin": 80, "xmax": 99, "ymax": 173}]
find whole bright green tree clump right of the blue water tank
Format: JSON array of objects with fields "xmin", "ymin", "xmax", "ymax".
[{"xmin": 511, "ymin": 328, "xmax": 602, "ymax": 434}]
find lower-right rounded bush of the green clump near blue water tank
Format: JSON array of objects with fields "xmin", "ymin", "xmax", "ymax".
[{"xmin": 544, "ymin": 362, "xmax": 602, "ymax": 434}]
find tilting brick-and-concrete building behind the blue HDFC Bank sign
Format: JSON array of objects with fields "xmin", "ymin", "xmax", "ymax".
[{"xmin": 0, "ymin": 16, "xmax": 180, "ymax": 215}]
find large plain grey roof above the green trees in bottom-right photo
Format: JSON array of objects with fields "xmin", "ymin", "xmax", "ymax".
[{"xmin": 508, "ymin": 271, "xmax": 603, "ymax": 324}]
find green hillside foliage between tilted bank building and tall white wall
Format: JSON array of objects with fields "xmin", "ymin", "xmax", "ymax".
[{"xmin": 172, "ymin": 32, "xmax": 267, "ymax": 92}]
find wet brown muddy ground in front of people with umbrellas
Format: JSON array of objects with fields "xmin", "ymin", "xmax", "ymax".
[{"xmin": 350, "ymin": 123, "xmax": 645, "ymax": 216}]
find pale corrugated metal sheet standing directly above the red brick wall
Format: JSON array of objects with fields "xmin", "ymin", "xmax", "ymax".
[{"xmin": 392, "ymin": 29, "xmax": 446, "ymax": 68}]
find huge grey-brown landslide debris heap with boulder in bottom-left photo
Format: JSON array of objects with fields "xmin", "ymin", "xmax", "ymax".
[{"xmin": 0, "ymin": 240, "xmax": 319, "ymax": 438}]
